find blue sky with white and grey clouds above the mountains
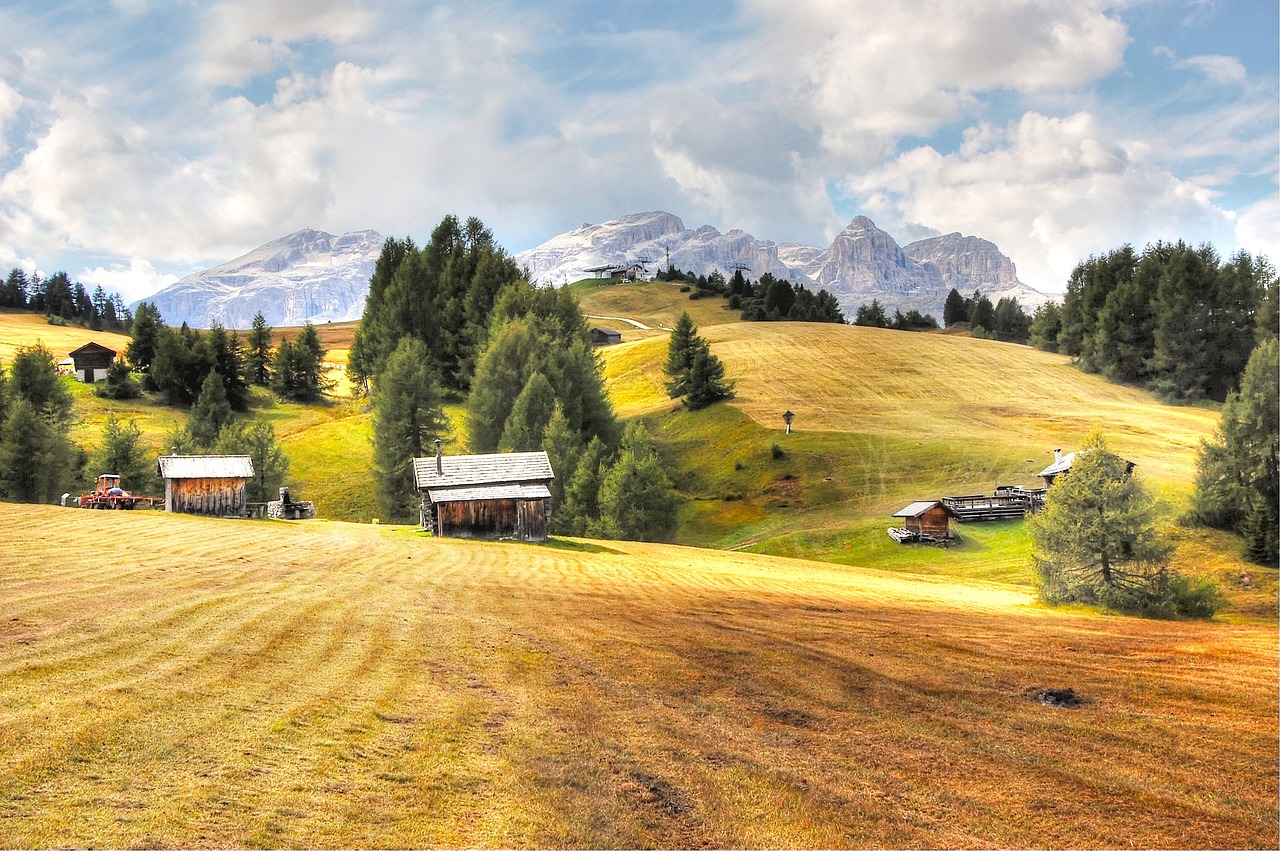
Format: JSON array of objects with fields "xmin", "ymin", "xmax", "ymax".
[{"xmin": 0, "ymin": 0, "xmax": 1280, "ymax": 301}]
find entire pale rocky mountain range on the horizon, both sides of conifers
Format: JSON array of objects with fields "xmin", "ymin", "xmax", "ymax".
[{"xmin": 137, "ymin": 211, "xmax": 1048, "ymax": 329}]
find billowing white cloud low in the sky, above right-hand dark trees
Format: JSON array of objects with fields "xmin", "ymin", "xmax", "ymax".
[{"xmin": 845, "ymin": 113, "xmax": 1235, "ymax": 292}]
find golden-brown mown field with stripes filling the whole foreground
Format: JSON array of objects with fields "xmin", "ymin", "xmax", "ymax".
[{"xmin": 0, "ymin": 504, "xmax": 1280, "ymax": 847}]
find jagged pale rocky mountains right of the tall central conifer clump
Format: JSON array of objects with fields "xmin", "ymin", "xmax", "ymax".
[{"xmin": 515, "ymin": 211, "xmax": 1048, "ymax": 319}]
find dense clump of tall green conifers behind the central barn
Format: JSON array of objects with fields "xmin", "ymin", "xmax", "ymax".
[{"xmin": 360, "ymin": 215, "xmax": 677, "ymax": 540}]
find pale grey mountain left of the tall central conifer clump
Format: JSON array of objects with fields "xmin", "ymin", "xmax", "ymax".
[{"xmin": 143, "ymin": 229, "xmax": 383, "ymax": 329}]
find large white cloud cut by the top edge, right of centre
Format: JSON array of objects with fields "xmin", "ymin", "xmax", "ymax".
[{"xmin": 751, "ymin": 0, "xmax": 1128, "ymax": 161}]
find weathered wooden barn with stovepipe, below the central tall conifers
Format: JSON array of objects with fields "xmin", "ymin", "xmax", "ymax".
[{"xmin": 413, "ymin": 450, "xmax": 556, "ymax": 541}]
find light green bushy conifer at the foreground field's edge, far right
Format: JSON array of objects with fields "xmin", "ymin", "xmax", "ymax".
[{"xmin": 1029, "ymin": 433, "xmax": 1172, "ymax": 612}]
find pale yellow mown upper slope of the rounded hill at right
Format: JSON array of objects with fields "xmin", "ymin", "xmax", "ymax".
[{"xmin": 602, "ymin": 322, "xmax": 1219, "ymax": 491}]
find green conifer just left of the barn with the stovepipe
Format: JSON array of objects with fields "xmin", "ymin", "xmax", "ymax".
[{"xmin": 374, "ymin": 337, "xmax": 448, "ymax": 520}]
